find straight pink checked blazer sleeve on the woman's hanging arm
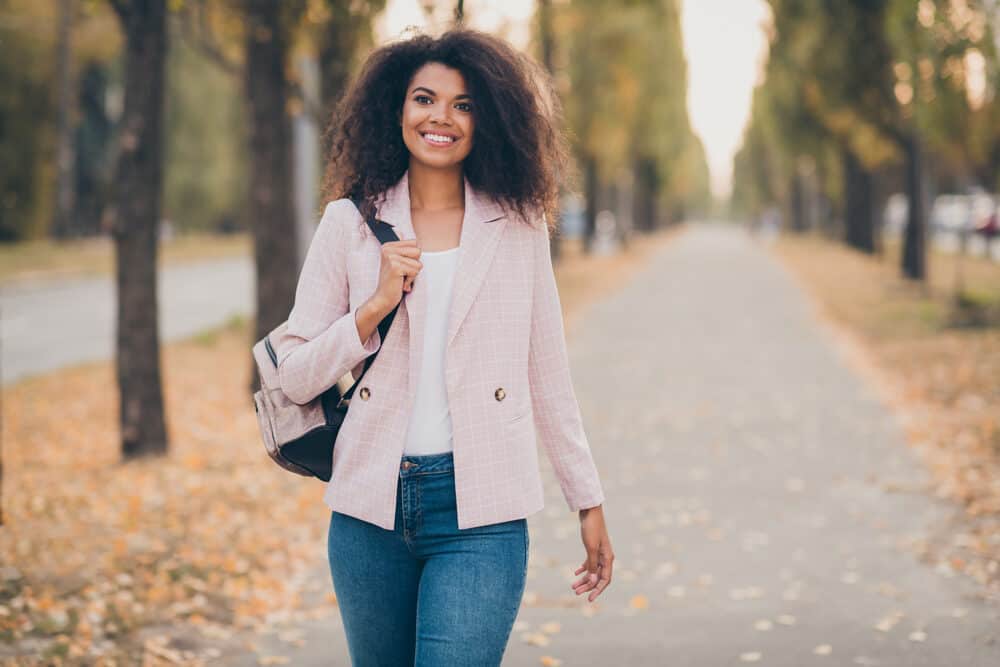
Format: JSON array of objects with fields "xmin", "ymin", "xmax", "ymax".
[{"xmin": 528, "ymin": 225, "xmax": 604, "ymax": 511}]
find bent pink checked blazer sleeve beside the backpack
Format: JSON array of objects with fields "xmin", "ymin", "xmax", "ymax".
[{"xmin": 276, "ymin": 199, "xmax": 382, "ymax": 405}]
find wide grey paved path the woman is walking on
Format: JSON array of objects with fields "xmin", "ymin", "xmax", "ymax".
[{"xmin": 230, "ymin": 226, "xmax": 1000, "ymax": 667}]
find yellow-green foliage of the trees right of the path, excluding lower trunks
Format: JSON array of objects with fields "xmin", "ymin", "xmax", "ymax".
[{"xmin": 734, "ymin": 0, "xmax": 1000, "ymax": 219}]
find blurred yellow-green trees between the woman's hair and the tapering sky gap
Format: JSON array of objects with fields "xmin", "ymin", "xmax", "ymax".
[{"xmin": 556, "ymin": 0, "xmax": 711, "ymax": 249}]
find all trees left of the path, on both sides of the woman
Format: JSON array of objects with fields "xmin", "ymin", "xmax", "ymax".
[{"xmin": 0, "ymin": 0, "xmax": 709, "ymax": 490}]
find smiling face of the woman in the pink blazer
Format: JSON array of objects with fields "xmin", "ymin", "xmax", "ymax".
[{"xmin": 400, "ymin": 63, "xmax": 474, "ymax": 169}]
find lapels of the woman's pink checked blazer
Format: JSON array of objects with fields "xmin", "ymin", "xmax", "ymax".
[{"xmin": 378, "ymin": 172, "xmax": 507, "ymax": 395}]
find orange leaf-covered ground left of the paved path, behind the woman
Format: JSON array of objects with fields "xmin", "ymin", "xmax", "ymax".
[{"xmin": 0, "ymin": 231, "xmax": 675, "ymax": 666}]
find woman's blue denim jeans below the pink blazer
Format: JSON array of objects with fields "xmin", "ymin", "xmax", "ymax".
[{"xmin": 327, "ymin": 452, "xmax": 528, "ymax": 667}]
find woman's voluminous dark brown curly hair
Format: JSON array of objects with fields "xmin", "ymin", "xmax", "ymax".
[{"xmin": 323, "ymin": 28, "xmax": 568, "ymax": 230}]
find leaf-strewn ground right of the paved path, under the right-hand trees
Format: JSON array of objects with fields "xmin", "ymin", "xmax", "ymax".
[{"xmin": 774, "ymin": 237, "xmax": 1000, "ymax": 592}]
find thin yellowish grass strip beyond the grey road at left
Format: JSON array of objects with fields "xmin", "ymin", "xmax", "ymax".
[{"xmin": 0, "ymin": 233, "xmax": 251, "ymax": 285}]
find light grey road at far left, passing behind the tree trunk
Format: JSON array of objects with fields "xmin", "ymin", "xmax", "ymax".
[{"xmin": 0, "ymin": 258, "xmax": 255, "ymax": 384}]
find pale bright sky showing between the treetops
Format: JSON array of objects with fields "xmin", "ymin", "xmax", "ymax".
[{"xmin": 376, "ymin": 0, "xmax": 770, "ymax": 198}]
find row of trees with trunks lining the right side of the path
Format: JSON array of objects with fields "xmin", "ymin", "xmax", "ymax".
[{"xmin": 733, "ymin": 0, "xmax": 1000, "ymax": 279}]
